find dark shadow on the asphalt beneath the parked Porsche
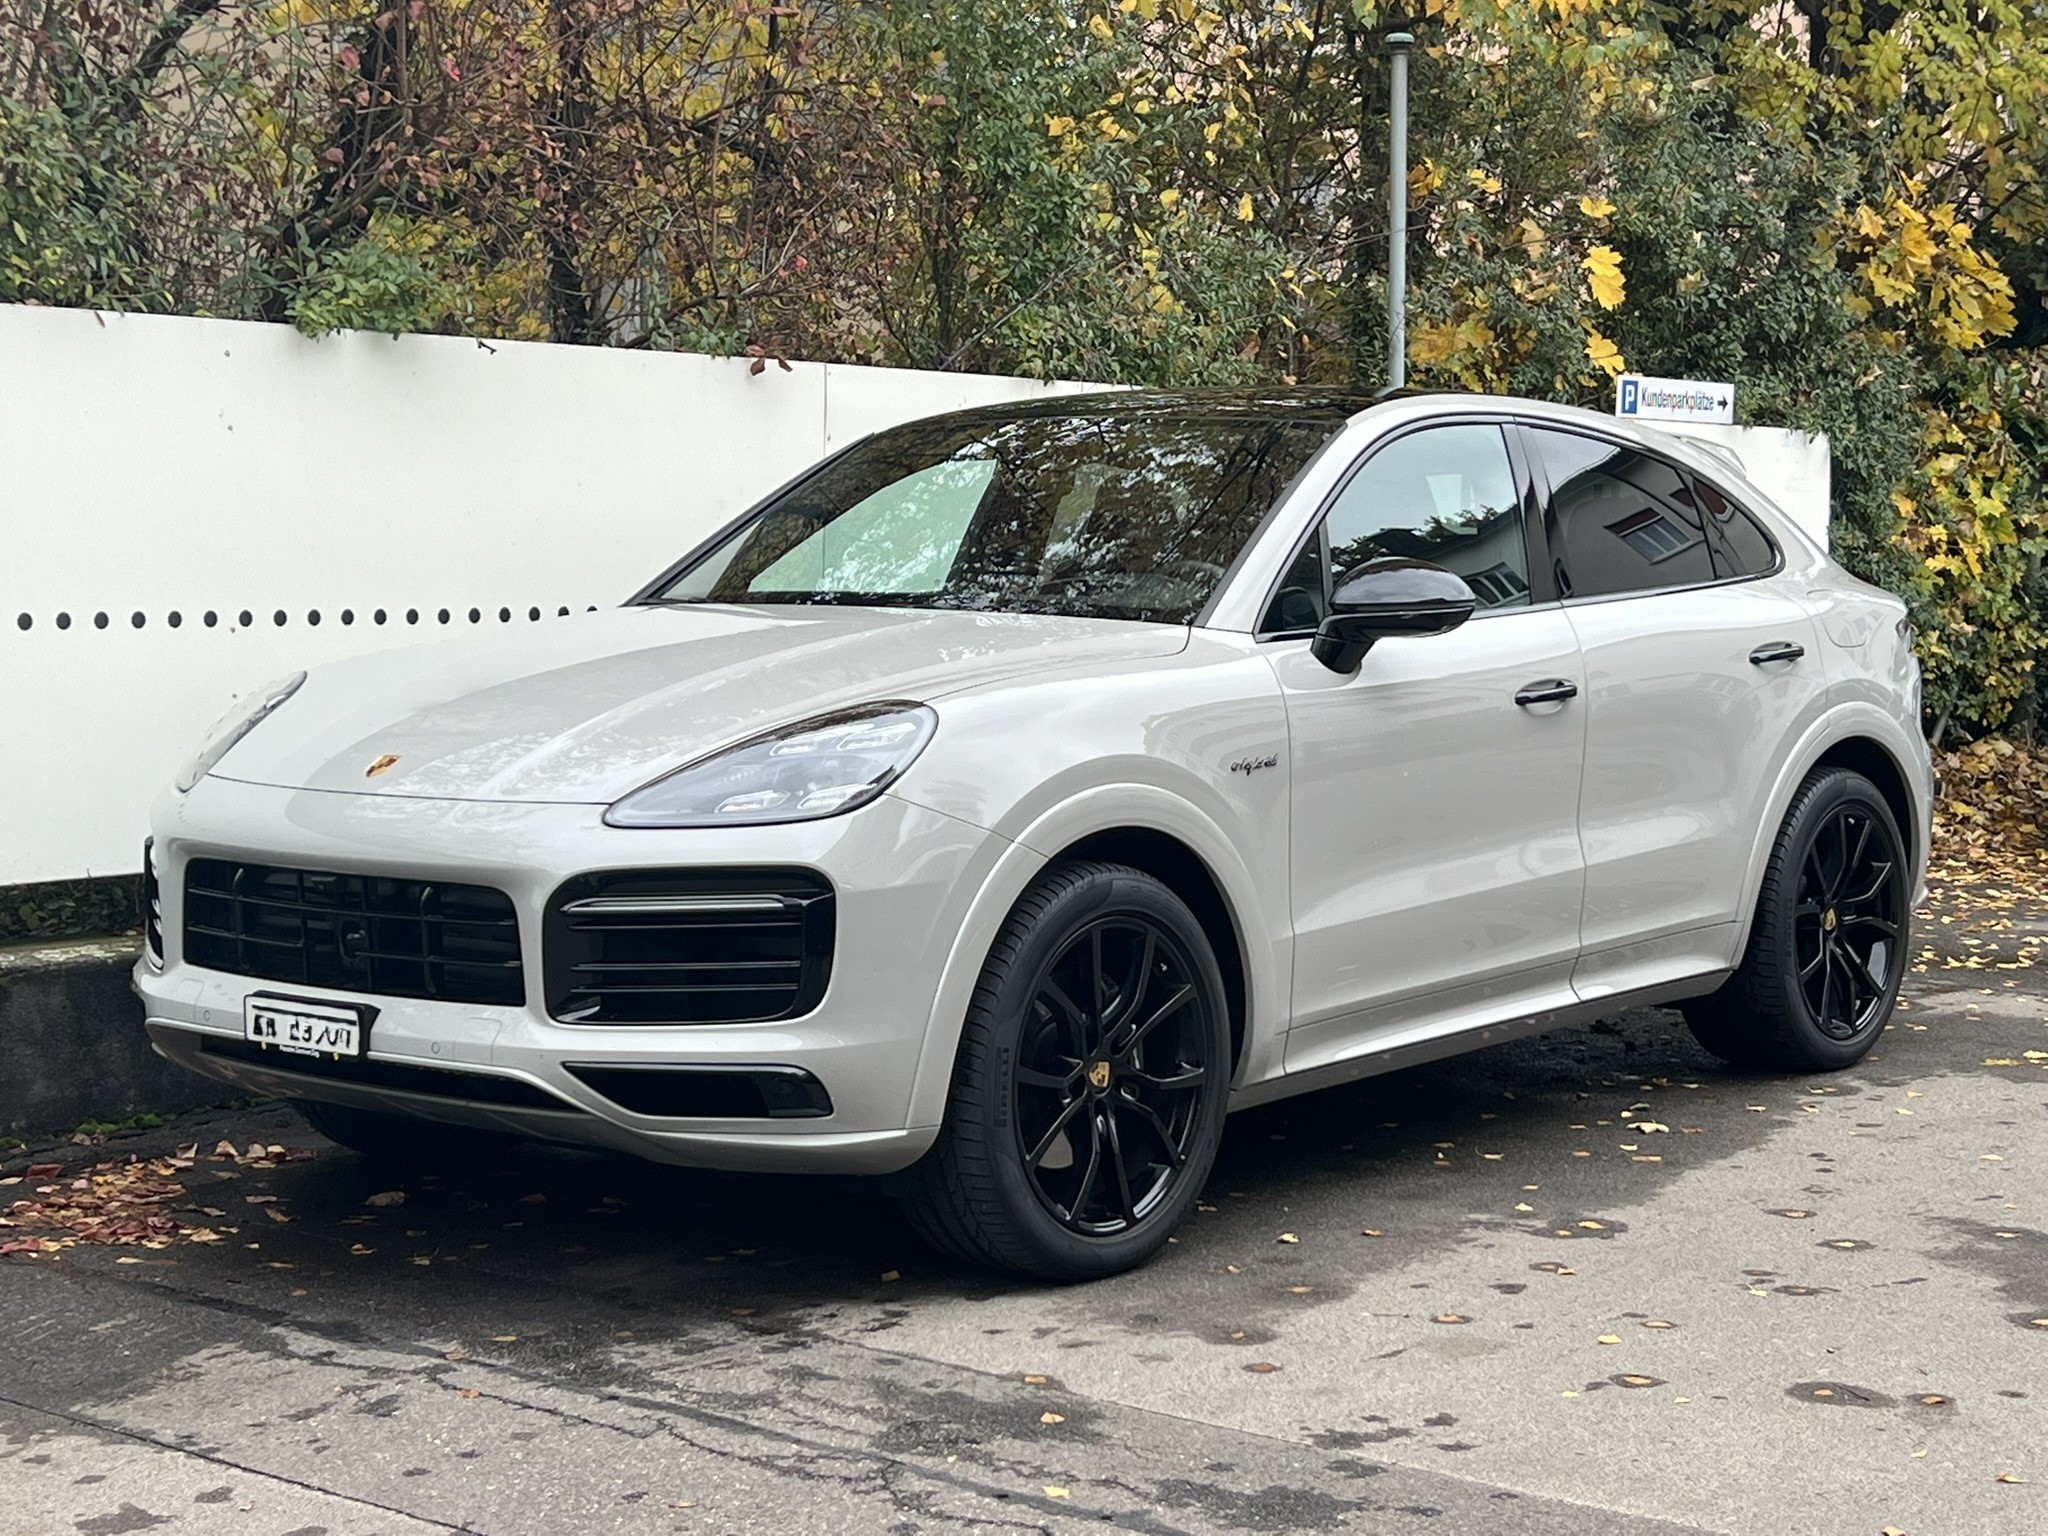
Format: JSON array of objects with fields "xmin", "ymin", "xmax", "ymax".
[{"xmin": 8, "ymin": 1010, "xmax": 1884, "ymax": 1333}]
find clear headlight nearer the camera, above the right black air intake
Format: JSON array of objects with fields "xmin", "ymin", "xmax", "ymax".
[{"xmin": 604, "ymin": 702, "xmax": 938, "ymax": 827}]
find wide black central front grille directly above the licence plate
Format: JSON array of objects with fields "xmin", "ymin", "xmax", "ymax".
[{"xmin": 184, "ymin": 858, "xmax": 526, "ymax": 1006}]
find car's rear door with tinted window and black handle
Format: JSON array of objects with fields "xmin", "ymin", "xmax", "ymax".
[{"xmin": 1524, "ymin": 426, "xmax": 1827, "ymax": 999}]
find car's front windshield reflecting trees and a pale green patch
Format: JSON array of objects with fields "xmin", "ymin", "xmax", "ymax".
[{"xmin": 653, "ymin": 412, "xmax": 1337, "ymax": 623}]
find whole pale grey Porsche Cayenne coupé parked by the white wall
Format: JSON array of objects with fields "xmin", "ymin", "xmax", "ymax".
[{"xmin": 137, "ymin": 393, "xmax": 1931, "ymax": 1278}]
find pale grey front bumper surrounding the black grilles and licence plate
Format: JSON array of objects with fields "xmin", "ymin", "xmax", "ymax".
[{"xmin": 135, "ymin": 778, "xmax": 1008, "ymax": 1174}]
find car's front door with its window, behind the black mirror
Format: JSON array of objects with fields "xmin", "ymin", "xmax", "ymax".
[{"xmin": 1270, "ymin": 422, "xmax": 1585, "ymax": 1071}]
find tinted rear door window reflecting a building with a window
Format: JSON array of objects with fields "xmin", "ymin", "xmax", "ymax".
[{"xmin": 1530, "ymin": 428, "xmax": 1716, "ymax": 598}]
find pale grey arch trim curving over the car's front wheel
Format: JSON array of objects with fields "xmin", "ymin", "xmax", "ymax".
[{"xmin": 907, "ymin": 784, "xmax": 1286, "ymax": 1126}]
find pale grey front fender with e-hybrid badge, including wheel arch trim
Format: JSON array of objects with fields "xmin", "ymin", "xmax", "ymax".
[{"xmin": 891, "ymin": 631, "xmax": 1288, "ymax": 1124}]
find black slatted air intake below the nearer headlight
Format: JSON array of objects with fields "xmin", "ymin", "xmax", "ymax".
[{"xmin": 541, "ymin": 868, "xmax": 834, "ymax": 1024}]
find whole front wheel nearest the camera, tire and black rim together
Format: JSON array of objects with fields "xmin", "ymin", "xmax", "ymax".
[{"xmin": 899, "ymin": 862, "xmax": 1231, "ymax": 1280}]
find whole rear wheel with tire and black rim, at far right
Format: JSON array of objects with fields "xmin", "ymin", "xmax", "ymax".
[{"xmin": 1681, "ymin": 768, "xmax": 1913, "ymax": 1071}]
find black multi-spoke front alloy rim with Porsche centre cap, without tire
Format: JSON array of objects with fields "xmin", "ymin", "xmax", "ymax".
[{"xmin": 1014, "ymin": 915, "xmax": 1208, "ymax": 1237}]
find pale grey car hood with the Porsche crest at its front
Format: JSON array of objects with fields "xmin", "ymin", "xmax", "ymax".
[{"xmin": 213, "ymin": 604, "xmax": 1188, "ymax": 805}]
